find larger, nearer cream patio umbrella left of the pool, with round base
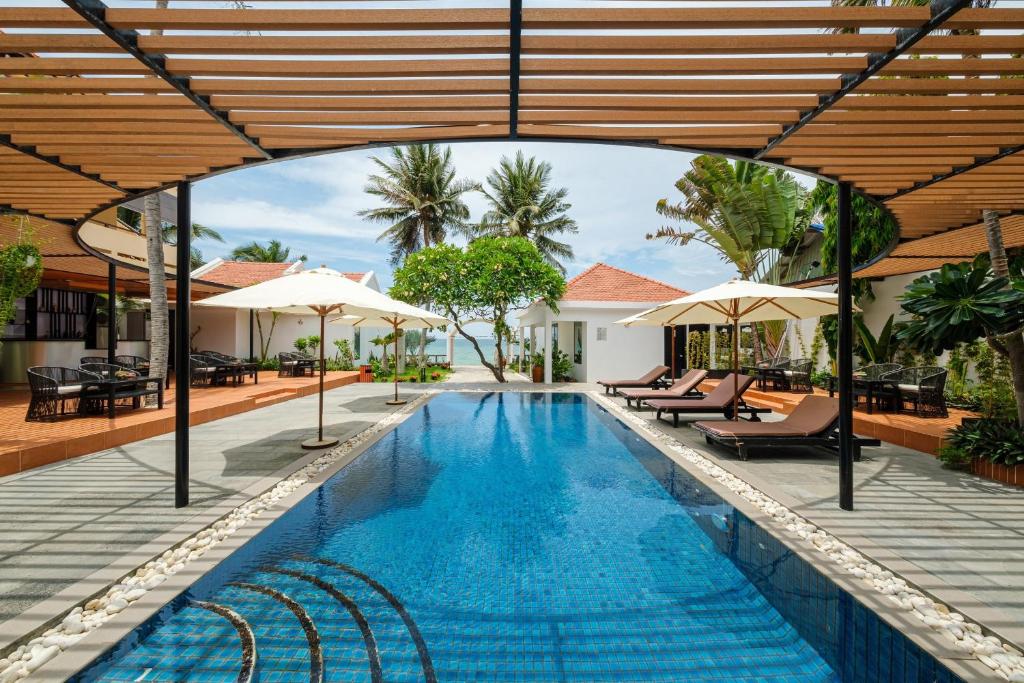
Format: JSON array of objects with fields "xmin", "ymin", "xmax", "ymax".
[{"xmin": 195, "ymin": 266, "xmax": 442, "ymax": 449}]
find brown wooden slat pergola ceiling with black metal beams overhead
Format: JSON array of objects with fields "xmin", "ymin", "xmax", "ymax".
[{"xmin": 0, "ymin": 0, "xmax": 1024, "ymax": 248}]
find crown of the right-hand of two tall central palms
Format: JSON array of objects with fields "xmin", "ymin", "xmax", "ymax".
[{"xmin": 476, "ymin": 152, "xmax": 580, "ymax": 274}]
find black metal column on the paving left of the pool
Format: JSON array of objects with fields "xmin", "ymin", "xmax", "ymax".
[{"xmin": 174, "ymin": 182, "xmax": 191, "ymax": 508}]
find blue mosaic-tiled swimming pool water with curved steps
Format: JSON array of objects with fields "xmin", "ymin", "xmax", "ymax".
[{"xmin": 80, "ymin": 393, "xmax": 956, "ymax": 682}]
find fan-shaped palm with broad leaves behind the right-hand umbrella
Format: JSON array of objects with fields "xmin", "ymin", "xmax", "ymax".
[{"xmin": 647, "ymin": 155, "xmax": 812, "ymax": 360}]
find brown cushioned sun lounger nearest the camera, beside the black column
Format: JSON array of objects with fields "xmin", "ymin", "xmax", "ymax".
[{"xmin": 693, "ymin": 396, "xmax": 881, "ymax": 460}]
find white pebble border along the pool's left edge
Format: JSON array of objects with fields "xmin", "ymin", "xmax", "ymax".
[{"xmin": 0, "ymin": 390, "xmax": 437, "ymax": 683}]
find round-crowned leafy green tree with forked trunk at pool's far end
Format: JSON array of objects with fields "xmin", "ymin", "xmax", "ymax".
[{"xmin": 390, "ymin": 238, "xmax": 565, "ymax": 382}]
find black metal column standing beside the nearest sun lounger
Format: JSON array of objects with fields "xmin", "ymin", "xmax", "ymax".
[{"xmin": 836, "ymin": 182, "xmax": 853, "ymax": 510}]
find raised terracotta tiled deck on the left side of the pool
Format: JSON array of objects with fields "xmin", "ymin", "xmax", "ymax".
[{"xmin": 0, "ymin": 372, "xmax": 359, "ymax": 476}]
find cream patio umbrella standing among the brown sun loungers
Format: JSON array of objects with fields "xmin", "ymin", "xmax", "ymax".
[{"xmin": 616, "ymin": 280, "xmax": 851, "ymax": 420}]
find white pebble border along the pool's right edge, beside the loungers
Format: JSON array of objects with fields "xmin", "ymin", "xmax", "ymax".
[{"xmin": 590, "ymin": 391, "xmax": 1024, "ymax": 683}]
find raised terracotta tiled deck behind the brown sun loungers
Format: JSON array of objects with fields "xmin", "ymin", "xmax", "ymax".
[{"xmin": 706, "ymin": 382, "xmax": 975, "ymax": 456}]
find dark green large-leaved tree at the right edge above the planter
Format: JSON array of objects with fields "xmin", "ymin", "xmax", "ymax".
[{"xmin": 898, "ymin": 256, "xmax": 1024, "ymax": 425}]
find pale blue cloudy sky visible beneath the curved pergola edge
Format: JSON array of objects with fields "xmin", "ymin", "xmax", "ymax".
[{"xmin": 194, "ymin": 142, "xmax": 815, "ymax": 290}]
